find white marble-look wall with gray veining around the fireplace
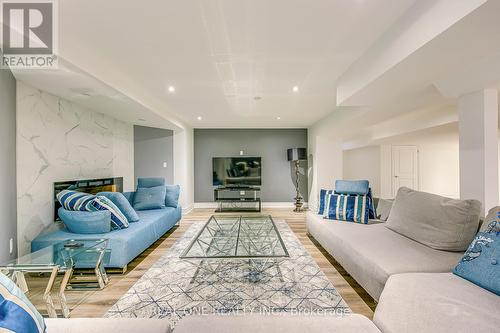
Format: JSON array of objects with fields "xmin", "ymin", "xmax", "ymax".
[{"xmin": 17, "ymin": 82, "xmax": 134, "ymax": 255}]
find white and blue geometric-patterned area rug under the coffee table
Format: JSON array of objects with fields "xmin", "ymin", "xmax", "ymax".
[{"xmin": 106, "ymin": 221, "xmax": 351, "ymax": 325}]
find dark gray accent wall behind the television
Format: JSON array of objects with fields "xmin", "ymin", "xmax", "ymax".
[{"xmin": 194, "ymin": 129, "xmax": 307, "ymax": 202}]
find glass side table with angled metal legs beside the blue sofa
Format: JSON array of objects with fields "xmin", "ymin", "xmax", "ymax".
[{"xmin": 0, "ymin": 239, "xmax": 109, "ymax": 318}]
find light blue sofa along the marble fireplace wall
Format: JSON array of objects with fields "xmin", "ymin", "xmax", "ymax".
[{"xmin": 31, "ymin": 180, "xmax": 182, "ymax": 269}]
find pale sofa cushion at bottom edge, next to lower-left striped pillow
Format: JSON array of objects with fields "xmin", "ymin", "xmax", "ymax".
[{"xmin": 46, "ymin": 318, "xmax": 171, "ymax": 333}]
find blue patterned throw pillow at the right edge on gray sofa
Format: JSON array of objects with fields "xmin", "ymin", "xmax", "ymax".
[{"xmin": 453, "ymin": 213, "xmax": 500, "ymax": 296}]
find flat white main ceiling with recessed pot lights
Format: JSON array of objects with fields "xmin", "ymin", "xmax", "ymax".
[{"xmin": 45, "ymin": 0, "xmax": 415, "ymax": 127}]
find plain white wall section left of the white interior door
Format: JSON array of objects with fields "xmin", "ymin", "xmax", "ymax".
[{"xmin": 344, "ymin": 146, "xmax": 381, "ymax": 197}]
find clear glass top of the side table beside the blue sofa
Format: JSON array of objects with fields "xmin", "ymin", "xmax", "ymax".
[{"xmin": 0, "ymin": 239, "xmax": 108, "ymax": 269}]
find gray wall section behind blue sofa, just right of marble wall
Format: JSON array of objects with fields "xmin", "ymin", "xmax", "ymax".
[{"xmin": 134, "ymin": 126, "xmax": 174, "ymax": 185}]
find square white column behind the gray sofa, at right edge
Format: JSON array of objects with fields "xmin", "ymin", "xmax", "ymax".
[{"xmin": 458, "ymin": 89, "xmax": 499, "ymax": 214}]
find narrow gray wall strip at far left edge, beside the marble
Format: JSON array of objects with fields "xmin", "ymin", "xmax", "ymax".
[{"xmin": 0, "ymin": 57, "xmax": 17, "ymax": 262}]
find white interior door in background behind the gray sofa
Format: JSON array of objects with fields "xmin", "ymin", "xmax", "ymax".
[{"xmin": 392, "ymin": 146, "xmax": 418, "ymax": 196}]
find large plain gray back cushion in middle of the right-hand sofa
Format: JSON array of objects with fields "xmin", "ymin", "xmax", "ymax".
[{"xmin": 385, "ymin": 187, "xmax": 481, "ymax": 251}]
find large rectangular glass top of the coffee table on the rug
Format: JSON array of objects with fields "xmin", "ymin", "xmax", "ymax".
[{"xmin": 181, "ymin": 215, "xmax": 289, "ymax": 258}]
